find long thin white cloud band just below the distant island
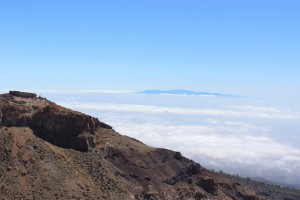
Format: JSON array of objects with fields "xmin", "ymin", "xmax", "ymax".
[{"xmin": 62, "ymin": 103, "xmax": 300, "ymax": 119}]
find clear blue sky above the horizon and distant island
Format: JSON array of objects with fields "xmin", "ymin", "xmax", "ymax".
[{"xmin": 0, "ymin": 0, "xmax": 300, "ymax": 97}]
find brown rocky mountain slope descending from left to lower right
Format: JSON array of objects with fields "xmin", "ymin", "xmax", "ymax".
[{"xmin": 0, "ymin": 91, "xmax": 258, "ymax": 200}]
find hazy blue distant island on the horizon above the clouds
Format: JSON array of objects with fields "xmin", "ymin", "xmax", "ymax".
[{"xmin": 137, "ymin": 89, "xmax": 241, "ymax": 97}]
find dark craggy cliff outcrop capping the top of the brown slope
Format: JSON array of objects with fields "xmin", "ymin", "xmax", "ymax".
[{"xmin": 0, "ymin": 91, "xmax": 111, "ymax": 151}]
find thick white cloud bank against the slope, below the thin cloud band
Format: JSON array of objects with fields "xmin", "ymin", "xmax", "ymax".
[{"xmin": 110, "ymin": 119, "xmax": 300, "ymax": 184}]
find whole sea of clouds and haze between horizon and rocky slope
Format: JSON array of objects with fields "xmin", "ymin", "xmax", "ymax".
[{"xmin": 44, "ymin": 92, "xmax": 300, "ymax": 184}]
